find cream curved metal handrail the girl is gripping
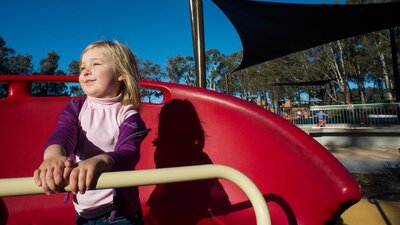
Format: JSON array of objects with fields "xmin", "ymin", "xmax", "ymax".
[{"xmin": 0, "ymin": 164, "xmax": 271, "ymax": 225}]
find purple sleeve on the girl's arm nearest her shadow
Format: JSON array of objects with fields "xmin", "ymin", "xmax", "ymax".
[{"xmin": 105, "ymin": 113, "xmax": 150, "ymax": 171}]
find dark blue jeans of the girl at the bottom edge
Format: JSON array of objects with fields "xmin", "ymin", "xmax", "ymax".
[{"xmin": 76, "ymin": 213, "xmax": 143, "ymax": 225}]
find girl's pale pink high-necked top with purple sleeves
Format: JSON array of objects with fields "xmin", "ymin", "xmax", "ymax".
[{"xmin": 48, "ymin": 95, "xmax": 147, "ymax": 218}]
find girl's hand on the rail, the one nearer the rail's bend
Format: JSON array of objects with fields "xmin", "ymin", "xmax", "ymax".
[{"xmin": 69, "ymin": 154, "xmax": 113, "ymax": 194}]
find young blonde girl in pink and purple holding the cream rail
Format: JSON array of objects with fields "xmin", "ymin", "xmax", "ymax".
[{"xmin": 34, "ymin": 41, "xmax": 148, "ymax": 225}]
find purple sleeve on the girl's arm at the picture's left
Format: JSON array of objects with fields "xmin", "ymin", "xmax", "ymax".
[{"xmin": 46, "ymin": 100, "xmax": 80, "ymax": 157}]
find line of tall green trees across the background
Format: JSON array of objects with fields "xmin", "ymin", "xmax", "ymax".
[{"xmin": 0, "ymin": 7, "xmax": 400, "ymax": 104}]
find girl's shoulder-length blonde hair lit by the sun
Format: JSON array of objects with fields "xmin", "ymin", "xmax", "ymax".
[{"xmin": 79, "ymin": 40, "xmax": 142, "ymax": 110}]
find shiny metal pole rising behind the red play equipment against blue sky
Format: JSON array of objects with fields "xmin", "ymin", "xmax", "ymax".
[{"xmin": 189, "ymin": 0, "xmax": 206, "ymax": 88}]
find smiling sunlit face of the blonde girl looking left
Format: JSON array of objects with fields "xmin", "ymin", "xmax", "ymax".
[{"xmin": 79, "ymin": 47, "xmax": 122, "ymax": 98}]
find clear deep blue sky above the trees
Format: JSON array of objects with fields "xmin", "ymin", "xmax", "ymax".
[{"xmin": 0, "ymin": 0, "xmax": 338, "ymax": 72}]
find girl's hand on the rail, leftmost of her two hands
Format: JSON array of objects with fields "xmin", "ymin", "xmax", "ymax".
[{"xmin": 33, "ymin": 156, "xmax": 74, "ymax": 194}]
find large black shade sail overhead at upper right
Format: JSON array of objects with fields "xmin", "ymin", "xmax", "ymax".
[{"xmin": 213, "ymin": 0, "xmax": 400, "ymax": 70}]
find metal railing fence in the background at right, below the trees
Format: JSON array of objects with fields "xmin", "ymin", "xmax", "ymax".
[{"xmin": 280, "ymin": 103, "xmax": 400, "ymax": 128}]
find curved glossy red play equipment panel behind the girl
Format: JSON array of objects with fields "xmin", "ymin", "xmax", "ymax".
[{"xmin": 0, "ymin": 76, "xmax": 361, "ymax": 225}]
